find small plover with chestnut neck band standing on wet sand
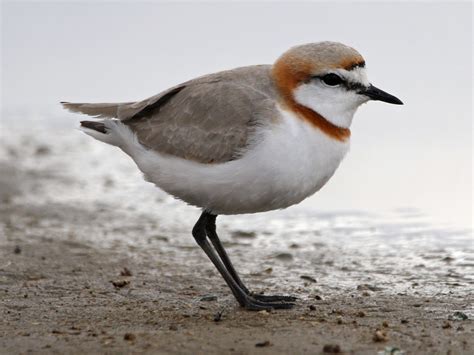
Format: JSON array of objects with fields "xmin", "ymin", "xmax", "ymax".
[{"xmin": 61, "ymin": 41, "xmax": 403, "ymax": 311}]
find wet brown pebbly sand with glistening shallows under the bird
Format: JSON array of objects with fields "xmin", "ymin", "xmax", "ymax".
[{"xmin": 0, "ymin": 133, "xmax": 474, "ymax": 354}]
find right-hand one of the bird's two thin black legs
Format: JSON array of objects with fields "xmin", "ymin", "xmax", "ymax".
[{"xmin": 204, "ymin": 212, "xmax": 296, "ymax": 302}]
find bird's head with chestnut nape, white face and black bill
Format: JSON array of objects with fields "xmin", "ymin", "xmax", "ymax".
[{"xmin": 272, "ymin": 42, "xmax": 403, "ymax": 134}]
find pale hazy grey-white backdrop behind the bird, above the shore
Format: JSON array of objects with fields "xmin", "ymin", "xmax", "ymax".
[{"xmin": 1, "ymin": 2, "xmax": 473, "ymax": 228}]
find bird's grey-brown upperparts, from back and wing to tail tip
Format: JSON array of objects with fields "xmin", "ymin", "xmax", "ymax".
[{"xmin": 63, "ymin": 65, "xmax": 278, "ymax": 163}]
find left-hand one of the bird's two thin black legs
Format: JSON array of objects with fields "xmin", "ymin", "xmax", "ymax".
[{"xmin": 193, "ymin": 212, "xmax": 293, "ymax": 311}]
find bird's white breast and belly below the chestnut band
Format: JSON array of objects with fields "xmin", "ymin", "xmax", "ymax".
[{"xmin": 128, "ymin": 111, "xmax": 349, "ymax": 214}]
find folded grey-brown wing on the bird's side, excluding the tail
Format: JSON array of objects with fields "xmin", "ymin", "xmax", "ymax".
[{"xmin": 123, "ymin": 81, "xmax": 275, "ymax": 163}]
